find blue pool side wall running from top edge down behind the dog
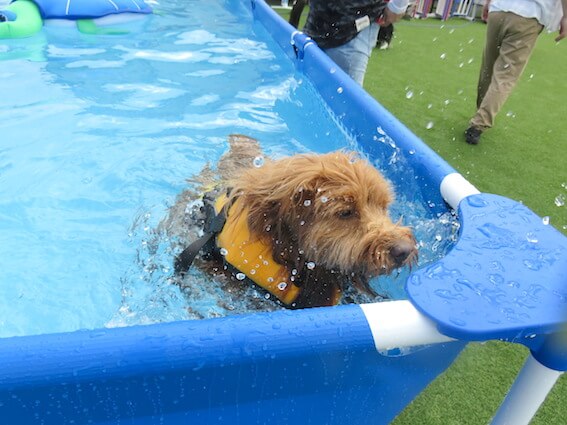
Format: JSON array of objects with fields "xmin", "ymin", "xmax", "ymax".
[{"xmin": 253, "ymin": 0, "xmax": 457, "ymax": 213}]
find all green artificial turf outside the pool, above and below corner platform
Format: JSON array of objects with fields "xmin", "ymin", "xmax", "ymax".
[{"xmin": 272, "ymin": 9, "xmax": 567, "ymax": 425}]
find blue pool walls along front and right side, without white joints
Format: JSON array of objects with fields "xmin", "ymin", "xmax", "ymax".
[{"xmin": 0, "ymin": 0, "xmax": 470, "ymax": 424}]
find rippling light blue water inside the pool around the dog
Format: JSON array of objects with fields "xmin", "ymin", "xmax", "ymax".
[{"xmin": 0, "ymin": 0, "xmax": 458, "ymax": 337}]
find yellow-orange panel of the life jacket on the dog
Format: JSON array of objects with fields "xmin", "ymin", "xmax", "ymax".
[{"xmin": 215, "ymin": 195, "xmax": 301, "ymax": 304}]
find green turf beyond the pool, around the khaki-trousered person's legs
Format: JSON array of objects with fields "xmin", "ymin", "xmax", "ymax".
[{"xmin": 365, "ymin": 19, "xmax": 567, "ymax": 234}]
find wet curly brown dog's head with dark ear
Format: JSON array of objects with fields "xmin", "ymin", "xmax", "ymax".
[{"xmin": 229, "ymin": 152, "xmax": 417, "ymax": 278}]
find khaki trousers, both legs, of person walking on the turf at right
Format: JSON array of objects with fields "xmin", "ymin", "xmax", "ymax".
[{"xmin": 470, "ymin": 12, "xmax": 543, "ymax": 130}]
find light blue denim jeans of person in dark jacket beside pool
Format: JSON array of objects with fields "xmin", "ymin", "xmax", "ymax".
[{"xmin": 325, "ymin": 22, "xmax": 380, "ymax": 86}]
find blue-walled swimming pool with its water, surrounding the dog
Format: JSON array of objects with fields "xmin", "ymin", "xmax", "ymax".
[{"xmin": 0, "ymin": 0, "xmax": 564, "ymax": 423}]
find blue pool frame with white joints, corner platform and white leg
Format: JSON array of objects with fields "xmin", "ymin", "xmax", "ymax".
[{"xmin": 0, "ymin": 0, "xmax": 567, "ymax": 425}]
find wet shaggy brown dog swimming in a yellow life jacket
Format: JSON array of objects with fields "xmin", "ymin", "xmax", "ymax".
[{"xmin": 170, "ymin": 135, "xmax": 417, "ymax": 308}]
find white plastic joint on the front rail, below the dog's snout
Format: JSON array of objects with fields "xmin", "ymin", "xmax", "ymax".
[{"xmin": 360, "ymin": 300, "xmax": 454, "ymax": 351}]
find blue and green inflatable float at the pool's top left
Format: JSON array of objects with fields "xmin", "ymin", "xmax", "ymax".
[{"xmin": 0, "ymin": 0, "xmax": 152, "ymax": 39}]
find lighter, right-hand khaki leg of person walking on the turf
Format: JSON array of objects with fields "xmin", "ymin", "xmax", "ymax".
[{"xmin": 470, "ymin": 13, "xmax": 543, "ymax": 130}]
